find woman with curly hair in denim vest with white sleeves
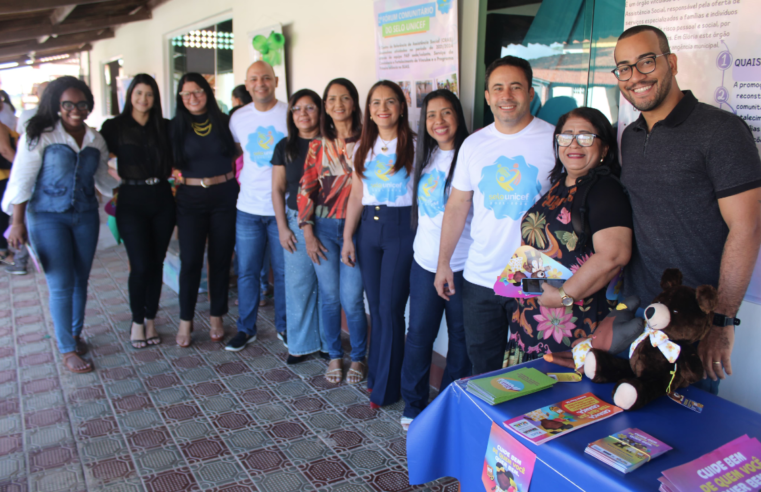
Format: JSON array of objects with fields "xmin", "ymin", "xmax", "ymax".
[{"xmin": 2, "ymin": 76, "xmax": 118, "ymax": 373}]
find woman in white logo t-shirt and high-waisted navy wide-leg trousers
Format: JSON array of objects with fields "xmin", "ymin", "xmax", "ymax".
[{"xmin": 341, "ymin": 80, "xmax": 415, "ymax": 408}]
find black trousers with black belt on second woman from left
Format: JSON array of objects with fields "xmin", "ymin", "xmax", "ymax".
[{"xmin": 116, "ymin": 182, "xmax": 175, "ymax": 324}]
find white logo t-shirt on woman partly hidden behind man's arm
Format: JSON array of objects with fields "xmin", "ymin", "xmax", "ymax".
[{"xmin": 412, "ymin": 148, "xmax": 473, "ymax": 273}]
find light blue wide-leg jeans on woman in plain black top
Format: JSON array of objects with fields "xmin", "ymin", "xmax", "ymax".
[{"xmin": 284, "ymin": 209, "xmax": 324, "ymax": 355}]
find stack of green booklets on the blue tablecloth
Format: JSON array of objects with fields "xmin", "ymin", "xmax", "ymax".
[{"xmin": 466, "ymin": 367, "xmax": 555, "ymax": 405}]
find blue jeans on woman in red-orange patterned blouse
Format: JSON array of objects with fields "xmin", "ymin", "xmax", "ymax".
[{"xmin": 314, "ymin": 218, "xmax": 367, "ymax": 362}]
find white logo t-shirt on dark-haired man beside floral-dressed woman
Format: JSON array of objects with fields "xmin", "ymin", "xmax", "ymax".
[{"xmin": 452, "ymin": 118, "xmax": 555, "ymax": 289}]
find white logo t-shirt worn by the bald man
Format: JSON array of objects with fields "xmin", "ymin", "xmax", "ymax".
[{"xmin": 230, "ymin": 101, "xmax": 288, "ymax": 215}]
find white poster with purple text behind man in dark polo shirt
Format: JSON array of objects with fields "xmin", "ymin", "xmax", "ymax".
[{"xmin": 619, "ymin": 0, "xmax": 761, "ymax": 304}]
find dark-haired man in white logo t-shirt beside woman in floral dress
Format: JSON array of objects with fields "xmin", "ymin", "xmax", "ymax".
[{"xmin": 435, "ymin": 56, "xmax": 555, "ymax": 374}]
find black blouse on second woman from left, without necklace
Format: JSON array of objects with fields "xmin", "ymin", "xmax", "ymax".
[{"xmin": 100, "ymin": 114, "xmax": 172, "ymax": 179}]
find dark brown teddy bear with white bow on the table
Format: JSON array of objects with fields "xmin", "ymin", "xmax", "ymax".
[{"xmin": 584, "ymin": 269, "xmax": 718, "ymax": 410}]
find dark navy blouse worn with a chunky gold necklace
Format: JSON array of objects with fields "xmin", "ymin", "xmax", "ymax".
[{"xmin": 172, "ymin": 113, "xmax": 233, "ymax": 178}]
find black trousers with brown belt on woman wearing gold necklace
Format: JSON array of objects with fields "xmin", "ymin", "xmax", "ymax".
[{"xmin": 177, "ymin": 179, "xmax": 240, "ymax": 321}]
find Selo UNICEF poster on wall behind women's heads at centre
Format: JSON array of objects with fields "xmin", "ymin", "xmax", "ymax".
[{"xmin": 375, "ymin": 0, "xmax": 460, "ymax": 131}]
